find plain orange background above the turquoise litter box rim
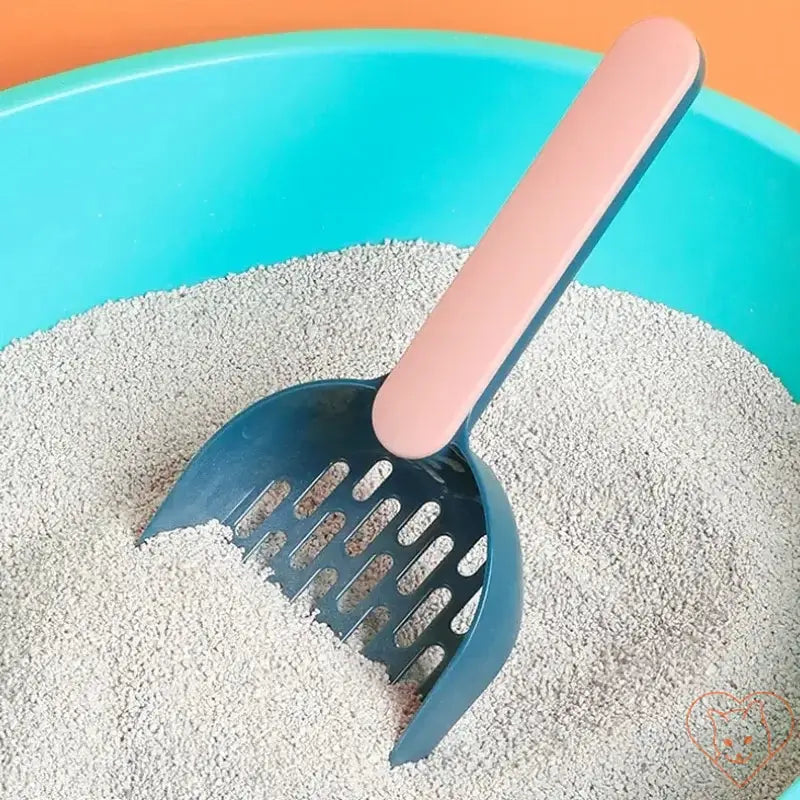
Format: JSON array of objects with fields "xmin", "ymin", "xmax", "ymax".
[{"xmin": 0, "ymin": 0, "xmax": 800, "ymax": 129}]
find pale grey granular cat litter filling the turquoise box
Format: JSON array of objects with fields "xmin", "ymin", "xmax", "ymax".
[{"xmin": 0, "ymin": 242, "xmax": 800, "ymax": 800}]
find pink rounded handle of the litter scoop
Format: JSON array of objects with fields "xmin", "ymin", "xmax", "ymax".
[{"xmin": 372, "ymin": 19, "xmax": 702, "ymax": 458}]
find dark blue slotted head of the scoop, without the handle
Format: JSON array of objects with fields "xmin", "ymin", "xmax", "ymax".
[{"xmin": 142, "ymin": 381, "xmax": 522, "ymax": 764}]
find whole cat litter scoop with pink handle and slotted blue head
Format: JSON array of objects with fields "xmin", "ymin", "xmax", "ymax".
[{"xmin": 142, "ymin": 19, "xmax": 703, "ymax": 764}]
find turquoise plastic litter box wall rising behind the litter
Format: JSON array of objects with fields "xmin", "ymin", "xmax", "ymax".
[{"xmin": 0, "ymin": 31, "xmax": 800, "ymax": 397}]
